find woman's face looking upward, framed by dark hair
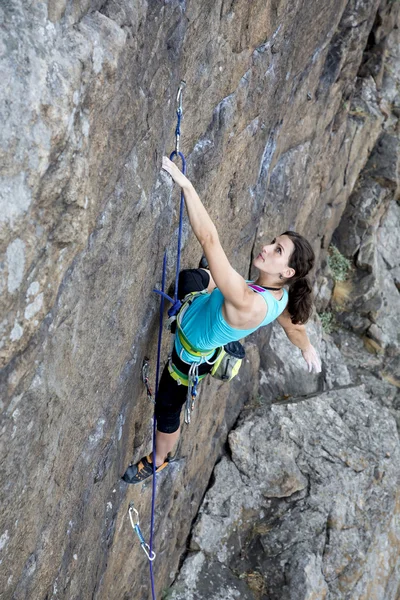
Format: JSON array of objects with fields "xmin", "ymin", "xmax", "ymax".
[{"xmin": 253, "ymin": 235, "xmax": 295, "ymax": 279}]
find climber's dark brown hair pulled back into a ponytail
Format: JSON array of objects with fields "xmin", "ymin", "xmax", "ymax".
[{"xmin": 282, "ymin": 231, "xmax": 315, "ymax": 325}]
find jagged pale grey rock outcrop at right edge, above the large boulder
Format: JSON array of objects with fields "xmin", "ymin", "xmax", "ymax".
[{"xmin": 335, "ymin": 144, "xmax": 400, "ymax": 349}]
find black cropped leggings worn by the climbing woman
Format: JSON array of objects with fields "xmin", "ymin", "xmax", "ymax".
[{"xmin": 156, "ymin": 269, "xmax": 212, "ymax": 433}]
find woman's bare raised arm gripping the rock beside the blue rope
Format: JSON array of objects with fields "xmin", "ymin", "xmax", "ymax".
[{"xmin": 163, "ymin": 157, "xmax": 255, "ymax": 310}]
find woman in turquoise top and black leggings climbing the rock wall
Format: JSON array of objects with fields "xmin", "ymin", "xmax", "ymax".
[{"xmin": 123, "ymin": 157, "xmax": 321, "ymax": 483}]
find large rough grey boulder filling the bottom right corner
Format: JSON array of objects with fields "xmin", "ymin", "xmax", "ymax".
[{"xmin": 170, "ymin": 386, "xmax": 400, "ymax": 600}]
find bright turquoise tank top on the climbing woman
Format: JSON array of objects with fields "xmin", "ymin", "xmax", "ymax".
[{"xmin": 175, "ymin": 282, "xmax": 288, "ymax": 363}]
